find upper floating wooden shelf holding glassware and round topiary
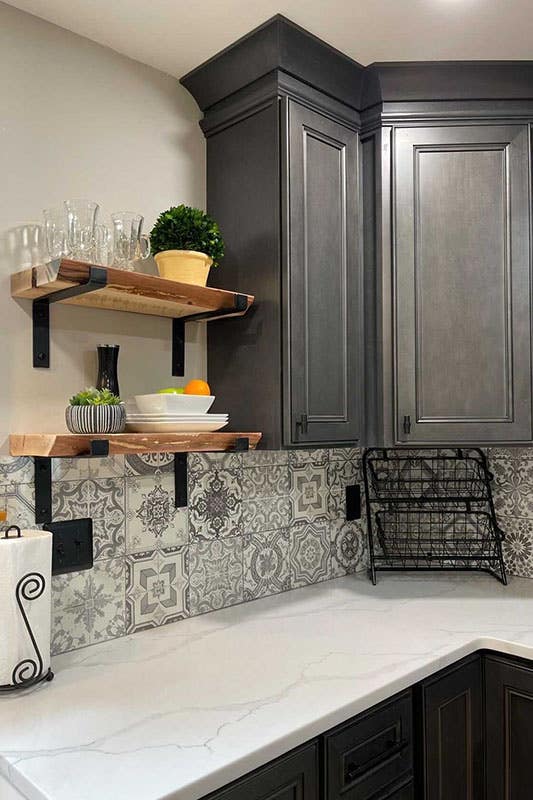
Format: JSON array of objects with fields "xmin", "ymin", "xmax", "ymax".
[{"xmin": 11, "ymin": 258, "xmax": 254, "ymax": 319}]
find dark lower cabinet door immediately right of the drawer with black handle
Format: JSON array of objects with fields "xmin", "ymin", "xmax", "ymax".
[{"xmin": 422, "ymin": 658, "xmax": 483, "ymax": 800}]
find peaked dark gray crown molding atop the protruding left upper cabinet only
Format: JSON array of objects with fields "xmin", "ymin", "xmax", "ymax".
[{"xmin": 181, "ymin": 14, "xmax": 364, "ymax": 112}]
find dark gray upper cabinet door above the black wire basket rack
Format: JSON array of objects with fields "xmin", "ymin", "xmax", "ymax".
[{"xmin": 394, "ymin": 125, "xmax": 532, "ymax": 442}]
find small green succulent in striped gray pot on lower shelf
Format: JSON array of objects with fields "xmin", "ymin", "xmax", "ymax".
[{"xmin": 65, "ymin": 386, "xmax": 126, "ymax": 433}]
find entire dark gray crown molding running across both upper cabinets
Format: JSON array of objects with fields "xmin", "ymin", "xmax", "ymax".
[{"xmin": 181, "ymin": 14, "xmax": 533, "ymax": 119}]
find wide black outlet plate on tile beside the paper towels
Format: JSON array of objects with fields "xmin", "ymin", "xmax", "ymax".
[{"xmin": 43, "ymin": 519, "xmax": 93, "ymax": 575}]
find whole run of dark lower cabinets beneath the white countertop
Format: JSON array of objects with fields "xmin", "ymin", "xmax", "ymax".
[{"xmin": 204, "ymin": 652, "xmax": 533, "ymax": 800}]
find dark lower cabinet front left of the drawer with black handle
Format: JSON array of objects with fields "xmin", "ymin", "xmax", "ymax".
[{"xmin": 204, "ymin": 742, "xmax": 319, "ymax": 800}]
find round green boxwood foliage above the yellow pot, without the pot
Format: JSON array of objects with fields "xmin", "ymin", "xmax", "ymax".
[{"xmin": 150, "ymin": 205, "xmax": 224, "ymax": 267}]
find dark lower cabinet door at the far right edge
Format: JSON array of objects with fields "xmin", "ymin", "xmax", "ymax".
[{"xmin": 485, "ymin": 658, "xmax": 533, "ymax": 800}]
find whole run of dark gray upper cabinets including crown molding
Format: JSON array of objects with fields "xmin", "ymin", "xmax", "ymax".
[{"xmin": 182, "ymin": 15, "xmax": 533, "ymax": 447}]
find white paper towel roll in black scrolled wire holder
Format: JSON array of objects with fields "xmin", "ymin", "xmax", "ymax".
[{"xmin": 0, "ymin": 530, "xmax": 52, "ymax": 686}]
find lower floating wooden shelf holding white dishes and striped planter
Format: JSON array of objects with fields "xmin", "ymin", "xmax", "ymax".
[{"xmin": 9, "ymin": 433, "xmax": 261, "ymax": 458}]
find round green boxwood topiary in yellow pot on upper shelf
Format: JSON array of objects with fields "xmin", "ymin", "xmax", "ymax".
[{"xmin": 150, "ymin": 205, "xmax": 224, "ymax": 286}]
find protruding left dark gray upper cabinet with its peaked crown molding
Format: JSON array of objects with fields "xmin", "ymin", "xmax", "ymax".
[{"xmin": 183, "ymin": 17, "xmax": 363, "ymax": 448}]
